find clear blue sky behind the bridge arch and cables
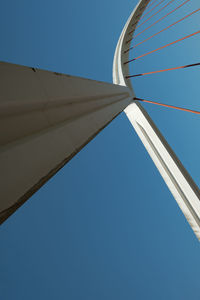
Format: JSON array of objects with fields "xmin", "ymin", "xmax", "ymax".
[{"xmin": 0, "ymin": 0, "xmax": 200, "ymax": 300}]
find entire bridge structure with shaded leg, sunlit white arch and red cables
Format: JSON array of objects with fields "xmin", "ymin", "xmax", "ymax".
[{"xmin": 0, "ymin": 0, "xmax": 200, "ymax": 239}]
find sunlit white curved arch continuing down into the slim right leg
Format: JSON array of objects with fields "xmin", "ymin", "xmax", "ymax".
[{"xmin": 113, "ymin": 0, "xmax": 200, "ymax": 240}]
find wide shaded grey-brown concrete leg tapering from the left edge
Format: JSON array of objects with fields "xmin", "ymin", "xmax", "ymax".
[{"xmin": 0, "ymin": 63, "xmax": 132, "ymax": 223}]
